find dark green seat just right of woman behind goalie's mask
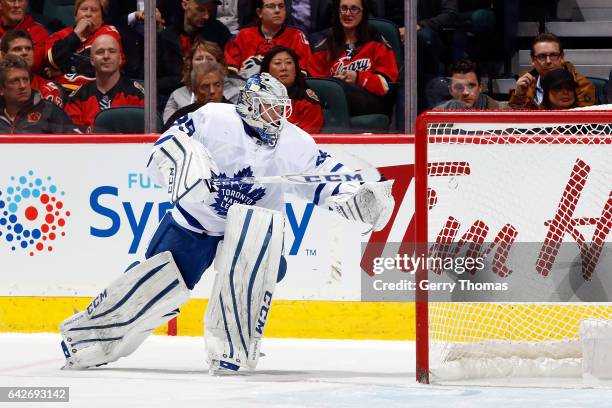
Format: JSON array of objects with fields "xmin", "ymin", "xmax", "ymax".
[{"xmin": 306, "ymin": 78, "xmax": 389, "ymax": 133}]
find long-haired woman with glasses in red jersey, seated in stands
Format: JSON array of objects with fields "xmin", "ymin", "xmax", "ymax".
[{"xmin": 312, "ymin": 0, "xmax": 398, "ymax": 115}]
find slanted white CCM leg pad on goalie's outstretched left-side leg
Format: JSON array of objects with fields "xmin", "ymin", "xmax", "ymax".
[{"xmin": 59, "ymin": 252, "xmax": 189, "ymax": 369}]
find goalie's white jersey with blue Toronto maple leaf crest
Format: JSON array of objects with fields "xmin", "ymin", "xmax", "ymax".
[{"xmin": 147, "ymin": 103, "xmax": 358, "ymax": 235}]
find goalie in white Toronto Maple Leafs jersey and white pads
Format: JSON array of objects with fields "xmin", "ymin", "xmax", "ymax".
[{"xmin": 60, "ymin": 73, "xmax": 394, "ymax": 372}]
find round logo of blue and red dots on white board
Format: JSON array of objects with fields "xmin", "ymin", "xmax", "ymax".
[{"xmin": 0, "ymin": 170, "xmax": 70, "ymax": 256}]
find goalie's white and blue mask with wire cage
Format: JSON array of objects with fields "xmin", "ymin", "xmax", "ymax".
[{"xmin": 236, "ymin": 72, "xmax": 291, "ymax": 147}]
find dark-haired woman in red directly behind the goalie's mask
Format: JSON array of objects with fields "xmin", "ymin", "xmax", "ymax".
[{"xmin": 261, "ymin": 46, "xmax": 323, "ymax": 134}]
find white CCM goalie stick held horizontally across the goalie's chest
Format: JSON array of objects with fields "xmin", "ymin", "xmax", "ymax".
[{"xmin": 210, "ymin": 167, "xmax": 381, "ymax": 186}]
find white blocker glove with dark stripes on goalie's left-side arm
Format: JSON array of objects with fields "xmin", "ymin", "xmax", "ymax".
[{"xmin": 151, "ymin": 130, "xmax": 218, "ymax": 203}]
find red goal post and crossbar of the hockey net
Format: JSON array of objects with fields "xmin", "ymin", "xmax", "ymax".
[{"xmin": 415, "ymin": 110, "xmax": 612, "ymax": 383}]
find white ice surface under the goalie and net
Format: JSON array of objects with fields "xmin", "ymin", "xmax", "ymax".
[{"xmin": 0, "ymin": 334, "xmax": 612, "ymax": 408}]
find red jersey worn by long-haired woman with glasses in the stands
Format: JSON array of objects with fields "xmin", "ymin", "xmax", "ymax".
[{"xmin": 311, "ymin": 36, "xmax": 398, "ymax": 96}]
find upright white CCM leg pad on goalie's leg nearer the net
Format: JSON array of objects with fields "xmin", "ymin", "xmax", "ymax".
[{"xmin": 204, "ymin": 204, "xmax": 284, "ymax": 371}]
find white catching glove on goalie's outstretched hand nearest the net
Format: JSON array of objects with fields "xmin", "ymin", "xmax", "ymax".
[{"xmin": 326, "ymin": 180, "xmax": 395, "ymax": 231}]
